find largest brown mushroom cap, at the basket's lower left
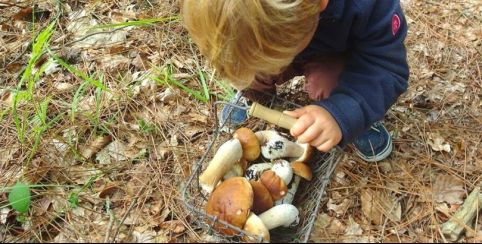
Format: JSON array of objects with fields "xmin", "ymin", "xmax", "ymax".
[{"xmin": 206, "ymin": 177, "xmax": 254, "ymax": 235}]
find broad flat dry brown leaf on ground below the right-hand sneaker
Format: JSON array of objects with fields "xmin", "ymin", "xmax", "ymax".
[{"xmin": 360, "ymin": 189, "xmax": 402, "ymax": 225}]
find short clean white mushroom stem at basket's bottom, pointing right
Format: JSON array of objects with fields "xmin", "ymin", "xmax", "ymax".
[{"xmin": 259, "ymin": 204, "xmax": 300, "ymax": 230}]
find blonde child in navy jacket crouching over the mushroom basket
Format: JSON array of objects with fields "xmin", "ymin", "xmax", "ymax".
[{"xmin": 182, "ymin": 0, "xmax": 409, "ymax": 162}]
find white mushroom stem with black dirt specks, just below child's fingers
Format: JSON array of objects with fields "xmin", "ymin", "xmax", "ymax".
[{"xmin": 255, "ymin": 130, "xmax": 305, "ymax": 159}]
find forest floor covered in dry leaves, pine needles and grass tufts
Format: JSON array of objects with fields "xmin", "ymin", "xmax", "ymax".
[{"xmin": 0, "ymin": 0, "xmax": 482, "ymax": 242}]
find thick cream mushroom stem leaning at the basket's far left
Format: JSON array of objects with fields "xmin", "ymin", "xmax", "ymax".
[{"xmin": 199, "ymin": 139, "xmax": 243, "ymax": 194}]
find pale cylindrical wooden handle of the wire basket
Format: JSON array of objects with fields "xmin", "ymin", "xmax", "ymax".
[{"xmin": 248, "ymin": 102, "xmax": 297, "ymax": 130}]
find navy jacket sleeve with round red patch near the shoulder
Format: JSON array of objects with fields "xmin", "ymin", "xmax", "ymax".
[{"xmin": 316, "ymin": 1, "xmax": 409, "ymax": 146}]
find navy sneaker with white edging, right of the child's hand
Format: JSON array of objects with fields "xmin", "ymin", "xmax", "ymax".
[{"xmin": 353, "ymin": 122, "xmax": 393, "ymax": 162}]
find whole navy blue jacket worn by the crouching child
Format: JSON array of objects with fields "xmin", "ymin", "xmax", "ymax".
[{"xmin": 296, "ymin": 0, "xmax": 409, "ymax": 146}]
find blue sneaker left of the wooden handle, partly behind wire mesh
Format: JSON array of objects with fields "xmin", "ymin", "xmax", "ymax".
[{"xmin": 218, "ymin": 93, "xmax": 248, "ymax": 128}]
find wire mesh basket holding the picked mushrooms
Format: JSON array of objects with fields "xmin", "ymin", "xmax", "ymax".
[{"xmin": 182, "ymin": 93, "xmax": 341, "ymax": 243}]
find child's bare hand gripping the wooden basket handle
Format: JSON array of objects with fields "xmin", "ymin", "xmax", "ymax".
[{"xmin": 284, "ymin": 105, "xmax": 342, "ymax": 152}]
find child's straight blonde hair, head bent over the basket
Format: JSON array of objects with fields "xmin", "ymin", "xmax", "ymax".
[{"xmin": 181, "ymin": 0, "xmax": 320, "ymax": 89}]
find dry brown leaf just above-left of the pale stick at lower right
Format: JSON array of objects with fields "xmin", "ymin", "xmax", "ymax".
[{"xmin": 432, "ymin": 174, "xmax": 465, "ymax": 204}]
